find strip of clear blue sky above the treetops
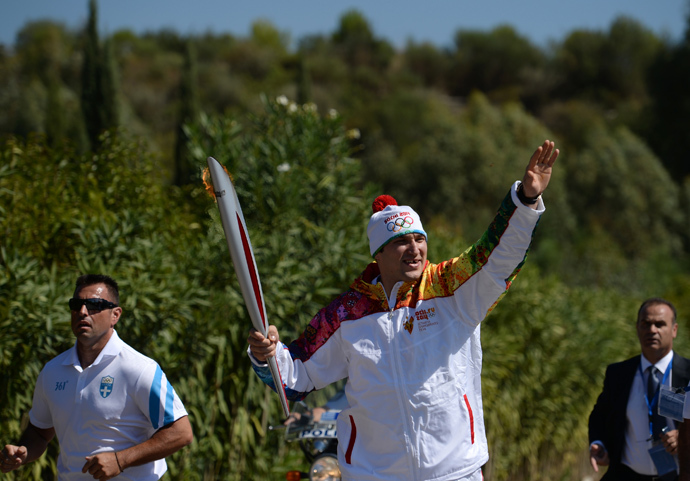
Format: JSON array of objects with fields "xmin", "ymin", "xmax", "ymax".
[{"xmin": 0, "ymin": 0, "xmax": 690, "ymax": 47}]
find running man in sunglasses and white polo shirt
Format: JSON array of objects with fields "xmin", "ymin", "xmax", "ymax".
[{"xmin": 0, "ymin": 274, "xmax": 193, "ymax": 481}]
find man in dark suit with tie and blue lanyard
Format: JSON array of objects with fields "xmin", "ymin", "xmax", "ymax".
[{"xmin": 589, "ymin": 298, "xmax": 690, "ymax": 481}]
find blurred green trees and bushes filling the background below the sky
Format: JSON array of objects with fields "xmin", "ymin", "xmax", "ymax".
[{"xmin": 0, "ymin": 0, "xmax": 690, "ymax": 481}]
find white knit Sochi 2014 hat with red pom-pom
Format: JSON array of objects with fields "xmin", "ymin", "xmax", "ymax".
[{"xmin": 367, "ymin": 195, "xmax": 427, "ymax": 257}]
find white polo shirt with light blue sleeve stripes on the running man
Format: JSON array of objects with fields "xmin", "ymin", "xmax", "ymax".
[{"xmin": 29, "ymin": 332, "xmax": 187, "ymax": 481}]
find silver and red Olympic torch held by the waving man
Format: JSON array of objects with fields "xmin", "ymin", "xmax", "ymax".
[{"xmin": 206, "ymin": 157, "xmax": 290, "ymax": 417}]
